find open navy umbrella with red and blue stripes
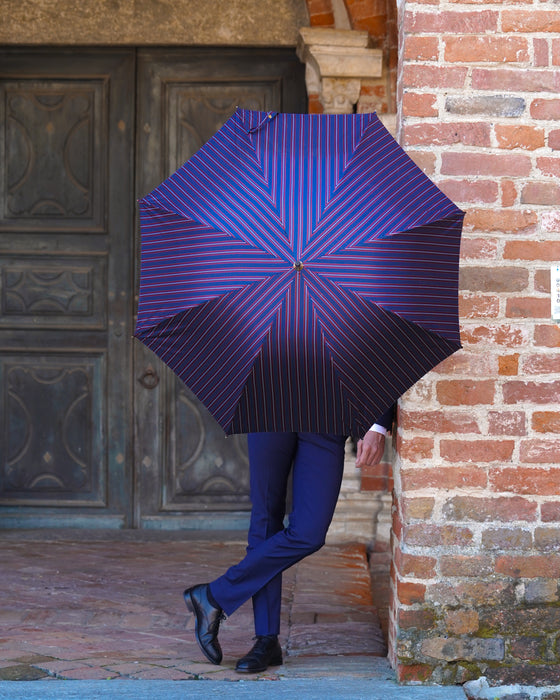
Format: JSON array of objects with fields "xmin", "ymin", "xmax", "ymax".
[{"xmin": 135, "ymin": 109, "xmax": 464, "ymax": 437}]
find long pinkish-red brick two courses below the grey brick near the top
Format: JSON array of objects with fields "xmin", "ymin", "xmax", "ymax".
[{"xmin": 441, "ymin": 151, "xmax": 532, "ymax": 178}]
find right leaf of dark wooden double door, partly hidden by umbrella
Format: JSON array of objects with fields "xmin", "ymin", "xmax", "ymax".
[{"xmin": 135, "ymin": 49, "xmax": 305, "ymax": 528}]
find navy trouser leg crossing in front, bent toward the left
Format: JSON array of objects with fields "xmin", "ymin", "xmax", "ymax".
[{"xmin": 210, "ymin": 433, "xmax": 345, "ymax": 615}]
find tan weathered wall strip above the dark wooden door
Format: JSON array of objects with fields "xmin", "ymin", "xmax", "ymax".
[{"xmin": 0, "ymin": 0, "xmax": 309, "ymax": 46}]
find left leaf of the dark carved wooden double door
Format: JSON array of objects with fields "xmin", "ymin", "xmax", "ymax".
[{"xmin": 0, "ymin": 50, "xmax": 134, "ymax": 527}]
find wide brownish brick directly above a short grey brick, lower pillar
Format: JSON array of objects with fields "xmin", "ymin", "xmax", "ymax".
[{"xmin": 443, "ymin": 496, "xmax": 538, "ymax": 522}]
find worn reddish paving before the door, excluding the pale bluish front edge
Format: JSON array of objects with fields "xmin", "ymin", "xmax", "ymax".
[{"xmin": 0, "ymin": 533, "xmax": 385, "ymax": 681}]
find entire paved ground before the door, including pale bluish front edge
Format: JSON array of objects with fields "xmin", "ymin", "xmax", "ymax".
[{"xmin": 0, "ymin": 530, "xmax": 464, "ymax": 700}]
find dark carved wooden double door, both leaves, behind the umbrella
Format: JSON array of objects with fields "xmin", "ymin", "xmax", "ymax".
[{"xmin": 0, "ymin": 47, "xmax": 306, "ymax": 529}]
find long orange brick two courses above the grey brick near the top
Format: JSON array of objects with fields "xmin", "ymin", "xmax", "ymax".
[{"xmin": 445, "ymin": 36, "xmax": 529, "ymax": 63}]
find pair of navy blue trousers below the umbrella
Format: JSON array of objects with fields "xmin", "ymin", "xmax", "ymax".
[{"xmin": 210, "ymin": 433, "xmax": 346, "ymax": 635}]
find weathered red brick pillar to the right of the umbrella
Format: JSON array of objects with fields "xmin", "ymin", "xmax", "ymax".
[{"xmin": 390, "ymin": 0, "xmax": 560, "ymax": 685}]
